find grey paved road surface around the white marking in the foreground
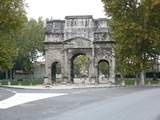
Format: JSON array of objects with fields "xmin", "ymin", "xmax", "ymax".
[{"xmin": 0, "ymin": 87, "xmax": 160, "ymax": 120}]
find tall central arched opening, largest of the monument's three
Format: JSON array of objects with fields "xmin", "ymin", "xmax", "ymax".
[{"xmin": 71, "ymin": 54, "xmax": 89, "ymax": 83}]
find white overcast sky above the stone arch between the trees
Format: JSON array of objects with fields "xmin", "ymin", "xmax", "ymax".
[{"xmin": 26, "ymin": 0, "xmax": 105, "ymax": 19}]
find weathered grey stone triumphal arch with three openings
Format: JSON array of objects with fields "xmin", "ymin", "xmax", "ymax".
[{"xmin": 44, "ymin": 16, "xmax": 115, "ymax": 83}]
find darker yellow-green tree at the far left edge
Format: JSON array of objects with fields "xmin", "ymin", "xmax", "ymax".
[{"xmin": 0, "ymin": 0, "xmax": 26, "ymax": 71}]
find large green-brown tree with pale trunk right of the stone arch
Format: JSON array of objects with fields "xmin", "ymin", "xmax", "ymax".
[{"xmin": 102, "ymin": 0, "xmax": 160, "ymax": 85}]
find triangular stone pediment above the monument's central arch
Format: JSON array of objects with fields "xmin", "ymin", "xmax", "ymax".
[{"xmin": 64, "ymin": 37, "xmax": 92, "ymax": 48}]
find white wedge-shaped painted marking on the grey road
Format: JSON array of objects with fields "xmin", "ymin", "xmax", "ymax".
[{"xmin": 0, "ymin": 93, "xmax": 66, "ymax": 109}]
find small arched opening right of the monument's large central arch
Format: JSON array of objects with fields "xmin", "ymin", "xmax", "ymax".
[{"xmin": 98, "ymin": 60, "xmax": 109, "ymax": 81}]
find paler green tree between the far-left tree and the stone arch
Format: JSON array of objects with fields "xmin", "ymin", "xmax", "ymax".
[{"xmin": 14, "ymin": 18, "xmax": 44, "ymax": 72}]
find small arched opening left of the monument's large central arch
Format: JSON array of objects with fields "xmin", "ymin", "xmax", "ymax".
[{"xmin": 51, "ymin": 62, "xmax": 62, "ymax": 82}]
